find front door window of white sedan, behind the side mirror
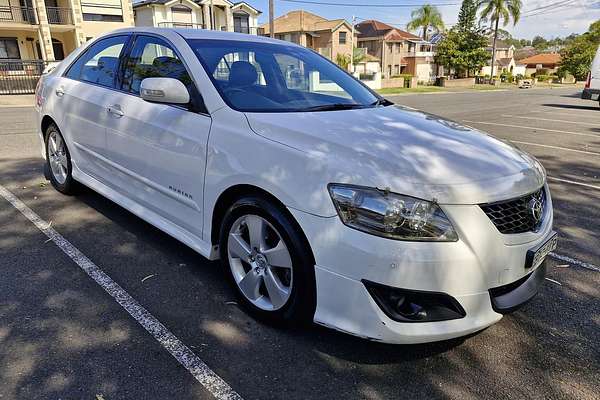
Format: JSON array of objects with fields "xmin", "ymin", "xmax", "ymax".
[{"xmin": 122, "ymin": 36, "xmax": 192, "ymax": 95}]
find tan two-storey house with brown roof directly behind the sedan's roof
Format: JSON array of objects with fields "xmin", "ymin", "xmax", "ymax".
[{"xmin": 261, "ymin": 10, "xmax": 356, "ymax": 61}]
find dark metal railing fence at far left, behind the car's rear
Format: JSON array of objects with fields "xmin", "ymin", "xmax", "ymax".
[{"xmin": 0, "ymin": 60, "xmax": 47, "ymax": 95}]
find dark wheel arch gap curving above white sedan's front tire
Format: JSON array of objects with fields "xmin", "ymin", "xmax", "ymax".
[{"xmin": 210, "ymin": 184, "xmax": 315, "ymax": 263}]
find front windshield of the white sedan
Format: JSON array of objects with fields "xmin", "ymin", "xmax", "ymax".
[{"xmin": 188, "ymin": 39, "xmax": 384, "ymax": 112}]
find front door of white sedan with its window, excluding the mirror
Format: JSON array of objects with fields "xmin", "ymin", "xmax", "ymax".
[{"xmin": 107, "ymin": 36, "xmax": 211, "ymax": 238}]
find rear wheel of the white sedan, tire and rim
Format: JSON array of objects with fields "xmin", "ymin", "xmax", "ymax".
[{"xmin": 46, "ymin": 124, "xmax": 76, "ymax": 194}]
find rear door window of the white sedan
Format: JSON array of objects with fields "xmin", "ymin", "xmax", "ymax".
[{"xmin": 66, "ymin": 36, "xmax": 128, "ymax": 88}]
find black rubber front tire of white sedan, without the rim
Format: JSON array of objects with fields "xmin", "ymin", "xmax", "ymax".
[{"xmin": 219, "ymin": 195, "xmax": 316, "ymax": 326}]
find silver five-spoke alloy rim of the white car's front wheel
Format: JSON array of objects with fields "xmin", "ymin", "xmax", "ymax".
[{"xmin": 227, "ymin": 215, "xmax": 293, "ymax": 311}]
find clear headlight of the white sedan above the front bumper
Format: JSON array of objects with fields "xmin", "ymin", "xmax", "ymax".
[{"xmin": 329, "ymin": 184, "xmax": 458, "ymax": 242}]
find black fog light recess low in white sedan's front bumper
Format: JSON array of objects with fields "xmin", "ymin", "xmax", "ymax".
[{"xmin": 362, "ymin": 279, "xmax": 467, "ymax": 322}]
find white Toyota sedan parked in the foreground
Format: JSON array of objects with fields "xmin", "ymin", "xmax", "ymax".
[{"xmin": 36, "ymin": 28, "xmax": 557, "ymax": 343}]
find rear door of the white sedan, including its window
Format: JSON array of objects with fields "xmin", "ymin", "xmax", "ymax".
[{"xmin": 58, "ymin": 35, "xmax": 129, "ymax": 180}]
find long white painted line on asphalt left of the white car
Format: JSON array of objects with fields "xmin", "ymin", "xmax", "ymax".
[{"xmin": 0, "ymin": 185, "xmax": 242, "ymax": 400}]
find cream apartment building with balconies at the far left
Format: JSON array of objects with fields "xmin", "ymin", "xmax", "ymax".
[{"xmin": 0, "ymin": 0, "xmax": 133, "ymax": 61}]
